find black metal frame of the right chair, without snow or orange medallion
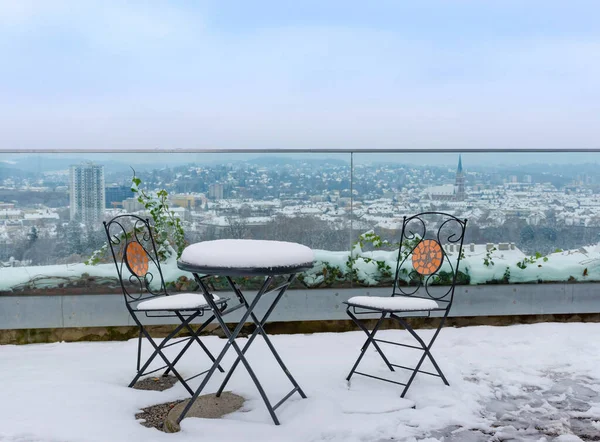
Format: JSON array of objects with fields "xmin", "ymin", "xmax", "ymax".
[{"xmin": 346, "ymin": 212, "xmax": 467, "ymax": 397}]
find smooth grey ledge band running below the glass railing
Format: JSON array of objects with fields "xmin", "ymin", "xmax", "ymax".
[{"xmin": 0, "ymin": 283, "xmax": 600, "ymax": 329}]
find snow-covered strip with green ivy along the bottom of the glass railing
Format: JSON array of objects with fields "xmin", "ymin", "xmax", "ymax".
[{"xmin": 0, "ymin": 242, "xmax": 600, "ymax": 296}]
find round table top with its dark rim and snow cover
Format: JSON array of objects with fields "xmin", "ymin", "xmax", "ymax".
[{"xmin": 177, "ymin": 239, "xmax": 314, "ymax": 276}]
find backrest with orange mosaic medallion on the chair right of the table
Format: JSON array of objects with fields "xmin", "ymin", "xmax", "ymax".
[{"xmin": 392, "ymin": 212, "xmax": 467, "ymax": 308}]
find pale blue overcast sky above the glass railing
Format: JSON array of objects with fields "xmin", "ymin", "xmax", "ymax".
[{"xmin": 0, "ymin": 0, "xmax": 600, "ymax": 149}]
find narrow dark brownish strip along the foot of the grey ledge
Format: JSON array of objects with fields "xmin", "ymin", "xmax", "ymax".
[{"xmin": 0, "ymin": 313, "xmax": 600, "ymax": 345}]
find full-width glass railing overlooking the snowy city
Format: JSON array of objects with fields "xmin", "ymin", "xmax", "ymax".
[{"xmin": 0, "ymin": 151, "xmax": 600, "ymax": 295}]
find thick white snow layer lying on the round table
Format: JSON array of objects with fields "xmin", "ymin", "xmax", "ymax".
[{"xmin": 179, "ymin": 239, "xmax": 314, "ymax": 268}]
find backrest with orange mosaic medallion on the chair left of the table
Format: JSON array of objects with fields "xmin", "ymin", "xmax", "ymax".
[{"xmin": 103, "ymin": 215, "xmax": 167, "ymax": 303}]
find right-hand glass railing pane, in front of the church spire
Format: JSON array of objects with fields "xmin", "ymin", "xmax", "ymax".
[{"xmin": 353, "ymin": 152, "xmax": 600, "ymax": 284}]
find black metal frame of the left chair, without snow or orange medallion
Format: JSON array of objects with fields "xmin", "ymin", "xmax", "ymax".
[{"xmin": 103, "ymin": 214, "xmax": 227, "ymax": 395}]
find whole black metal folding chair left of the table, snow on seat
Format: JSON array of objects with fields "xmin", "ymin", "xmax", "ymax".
[{"xmin": 103, "ymin": 215, "xmax": 228, "ymax": 395}]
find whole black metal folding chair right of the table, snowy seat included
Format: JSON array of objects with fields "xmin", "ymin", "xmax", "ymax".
[{"xmin": 346, "ymin": 212, "xmax": 467, "ymax": 397}]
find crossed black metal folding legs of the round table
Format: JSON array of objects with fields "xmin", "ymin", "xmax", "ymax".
[{"xmin": 177, "ymin": 263, "xmax": 312, "ymax": 425}]
